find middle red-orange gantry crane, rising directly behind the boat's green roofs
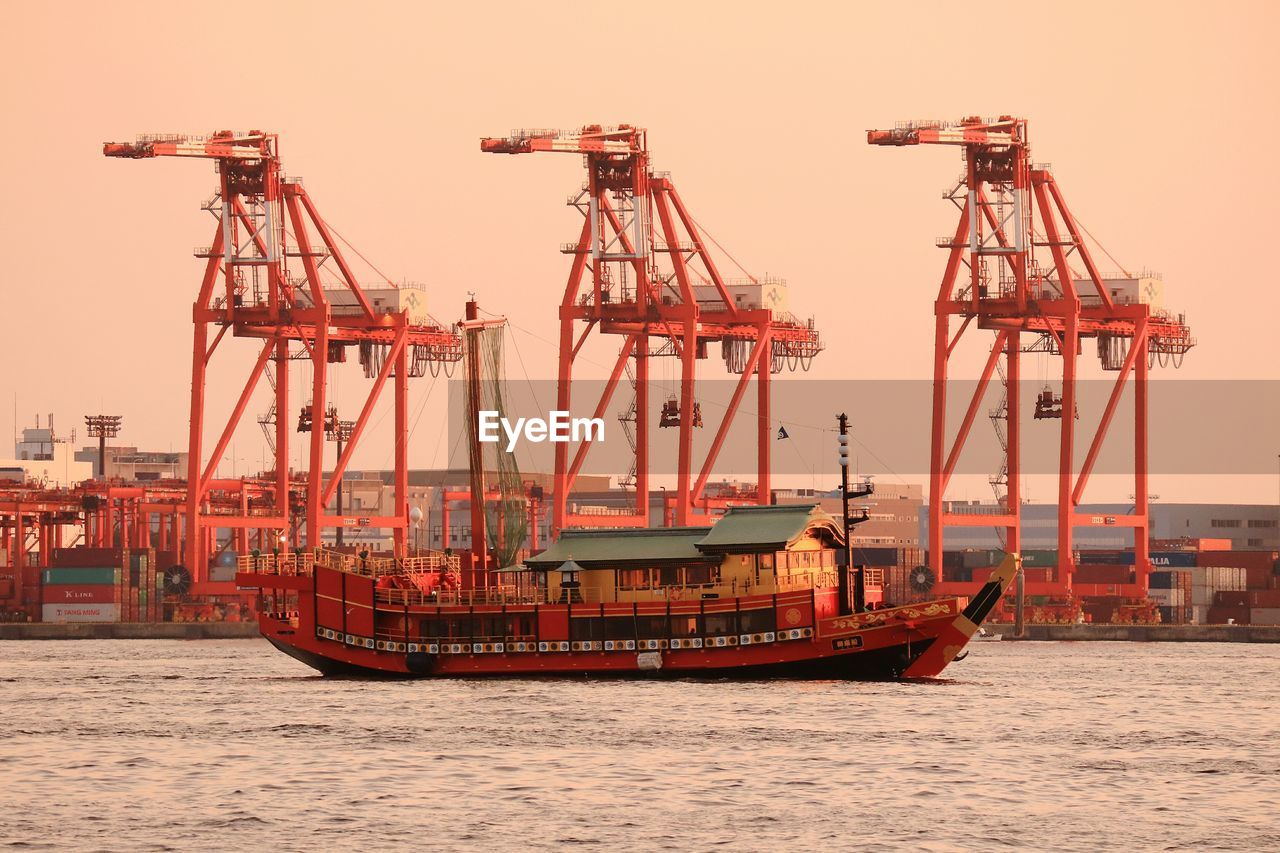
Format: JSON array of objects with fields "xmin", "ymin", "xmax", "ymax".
[{"xmin": 480, "ymin": 124, "xmax": 822, "ymax": 532}]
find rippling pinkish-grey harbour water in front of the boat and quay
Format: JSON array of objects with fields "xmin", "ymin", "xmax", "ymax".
[{"xmin": 0, "ymin": 640, "xmax": 1280, "ymax": 850}]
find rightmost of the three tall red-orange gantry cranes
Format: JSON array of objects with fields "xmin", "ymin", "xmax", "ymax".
[{"xmin": 867, "ymin": 115, "xmax": 1196, "ymax": 589}]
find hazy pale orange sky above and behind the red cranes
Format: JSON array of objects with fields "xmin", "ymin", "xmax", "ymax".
[{"xmin": 0, "ymin": 3, "xmax": 1280, "ymax": 502}]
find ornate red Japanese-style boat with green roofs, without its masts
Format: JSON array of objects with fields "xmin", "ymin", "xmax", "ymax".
[{"xmin": 236, "ymin": 506, "xmax": 1018, "ymax": 679}]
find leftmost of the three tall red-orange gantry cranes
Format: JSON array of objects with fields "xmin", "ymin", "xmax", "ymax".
[{"xmin": 102, "ymin": 131, "xmax": 462, "ymax": 583}]
